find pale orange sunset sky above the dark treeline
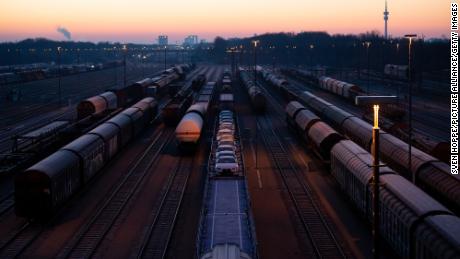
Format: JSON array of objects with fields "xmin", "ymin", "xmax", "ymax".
[{"xmin": 0, "ymin": 0, "xmax": 450, "ymax": 43}]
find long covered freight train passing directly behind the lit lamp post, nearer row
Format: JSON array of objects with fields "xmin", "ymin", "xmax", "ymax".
[{"xmin": 286, "ymin": 101, "xmax": 460, "ymax": 258}]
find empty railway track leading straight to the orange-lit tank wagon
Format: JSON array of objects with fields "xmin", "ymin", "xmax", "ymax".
[{"xmin": 137, "ymin": 157, "xmax": 193, "ymax": 258}]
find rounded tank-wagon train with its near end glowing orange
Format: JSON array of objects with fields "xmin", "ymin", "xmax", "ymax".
[{"xmin": 176, "ymin": 82, "xmax": 216, "ymax": 147}]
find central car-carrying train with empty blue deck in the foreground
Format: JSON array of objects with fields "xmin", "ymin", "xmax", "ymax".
[{"xmin": 197, "ymin": 109, "xmax": 257, "ymax": 259}]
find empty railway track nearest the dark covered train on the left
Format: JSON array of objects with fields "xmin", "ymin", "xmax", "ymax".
[{"xmin": 57, "ymin": 128, "xmax": 174, "ymax": 258}]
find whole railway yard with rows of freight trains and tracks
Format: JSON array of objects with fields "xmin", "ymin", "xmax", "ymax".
[{"xmin": 0, "ymin": 63, "xmax": 460, "ymax": 259}]
